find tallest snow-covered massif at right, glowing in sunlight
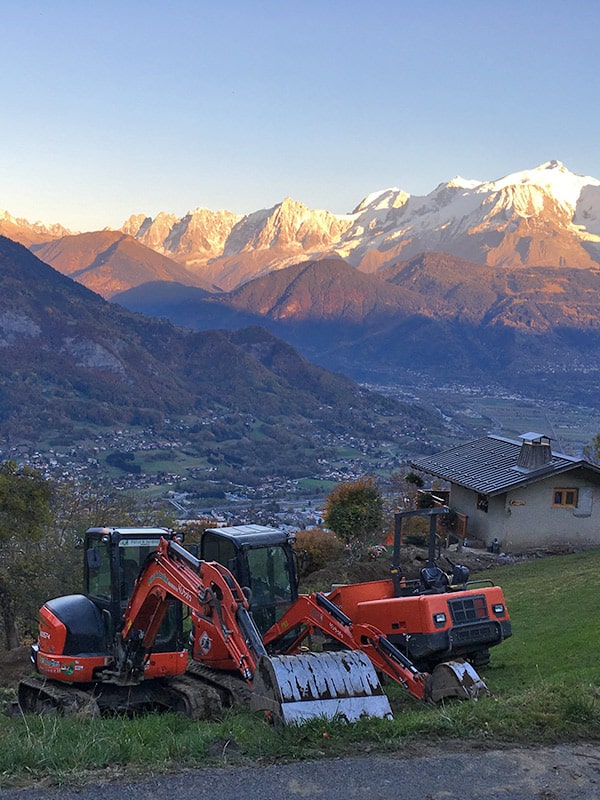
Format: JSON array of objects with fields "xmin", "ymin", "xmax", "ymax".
[{"xmin": 336, "ymin": 161, "xmax": 600, "ymax": 272}]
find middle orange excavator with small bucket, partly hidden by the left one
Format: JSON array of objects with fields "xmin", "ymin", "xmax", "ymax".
[{"xmin": 200, "ymin": 525, "xmax": 487, "ymax": 712}]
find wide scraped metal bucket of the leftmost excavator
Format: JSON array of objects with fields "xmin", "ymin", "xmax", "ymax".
[{"xmin": 251, "ymin": 650, "xmax": 392, "ymax": 725}]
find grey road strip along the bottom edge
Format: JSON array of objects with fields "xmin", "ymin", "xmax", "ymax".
[{"xmin": 0, "ymin": 742, "xmax": 600, "ymax": 800}]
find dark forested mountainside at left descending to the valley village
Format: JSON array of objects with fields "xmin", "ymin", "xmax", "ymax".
[{"xmin": 0, "ymin": 236, "xmax": 441, "ymax": 482}]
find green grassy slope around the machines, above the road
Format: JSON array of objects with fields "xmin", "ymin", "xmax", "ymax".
[{"xmin": 0, "ymin": 550, "xmax": 600, "ymax": 786}]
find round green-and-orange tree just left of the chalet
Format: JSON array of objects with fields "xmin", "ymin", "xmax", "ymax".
[{"xmin": 323, "ymin": 477, "xmax": 383, "ymax": 553}]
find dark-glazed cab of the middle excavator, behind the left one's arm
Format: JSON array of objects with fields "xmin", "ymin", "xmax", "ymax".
[{"xmin": 200, "ymin": 525, "xmax": 298, "ymax": 634}]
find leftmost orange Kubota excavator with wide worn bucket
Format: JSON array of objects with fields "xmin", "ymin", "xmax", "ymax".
[{"xmin": 19, "ymin": 528, "xmax": 391, "ymax": 723}]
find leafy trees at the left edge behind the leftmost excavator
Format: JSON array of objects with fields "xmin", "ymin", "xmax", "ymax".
[{"xmin": 0, "ymin": 468, "xmax": 170, "ymax": 649}]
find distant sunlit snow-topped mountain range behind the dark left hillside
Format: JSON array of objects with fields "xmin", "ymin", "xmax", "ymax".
[{"xmin": 0, "ymin": 161, "xmax": 600, "ymax": 406}]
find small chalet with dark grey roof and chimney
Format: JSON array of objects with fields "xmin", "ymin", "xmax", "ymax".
[{"xmin": 411, "ymin": 433, "xmax": 600, "ymax": 552}]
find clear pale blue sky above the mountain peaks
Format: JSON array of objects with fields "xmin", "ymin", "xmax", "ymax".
[{"xmin": 0, "ymin": 0, "xmax": 600, "ymax": 230}]
